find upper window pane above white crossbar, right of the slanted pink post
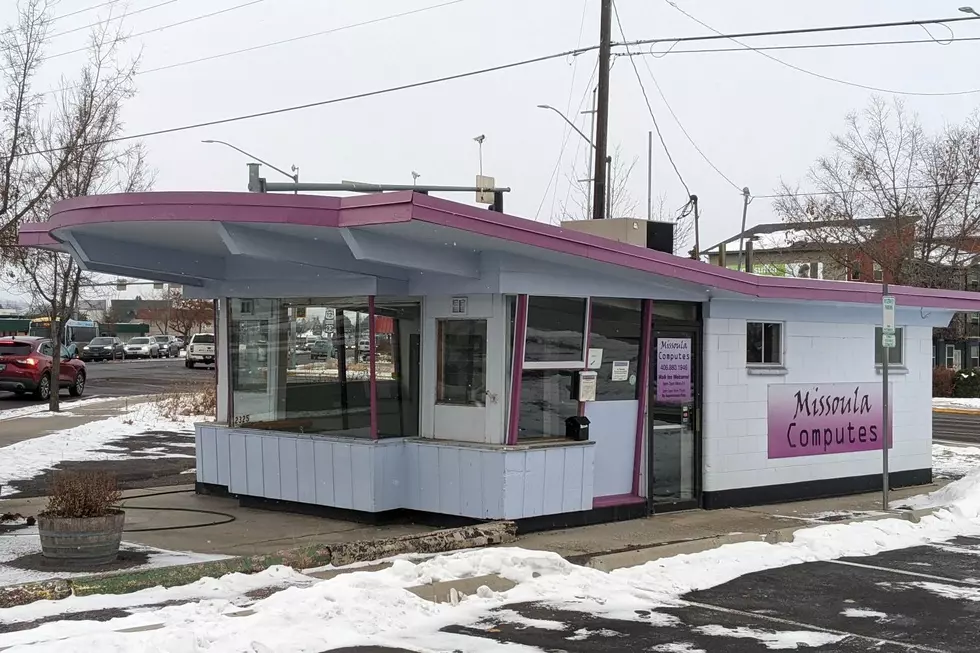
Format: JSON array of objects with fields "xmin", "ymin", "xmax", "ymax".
[{"xmin": 524, "ymin": 296, "xmax": 587, "ymax": 363}]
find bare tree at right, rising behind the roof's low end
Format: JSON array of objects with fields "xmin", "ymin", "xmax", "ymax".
[{"xmin": 774, "ymin": 98, "xmax": 980, "ymax": 287}]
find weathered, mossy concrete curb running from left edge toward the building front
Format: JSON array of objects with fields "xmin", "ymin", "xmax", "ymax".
[{"xmin": 0, "ymin": 522, "xmax": 517, "ymax": 608}]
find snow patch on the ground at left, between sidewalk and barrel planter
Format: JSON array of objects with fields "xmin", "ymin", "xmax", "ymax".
[{"xmin": 0, "ymin": 403, "xmax": 201, "ymax": 496}]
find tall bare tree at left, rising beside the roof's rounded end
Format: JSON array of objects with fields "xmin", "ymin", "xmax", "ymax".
[{"xmin": 0, "ymin": 7, "xmax": 152, "ymax": 410}]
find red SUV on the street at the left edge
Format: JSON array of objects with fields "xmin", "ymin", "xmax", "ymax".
[{"xmin": 0, "ymin": 336, "xmax": 85, "ymax": 401}]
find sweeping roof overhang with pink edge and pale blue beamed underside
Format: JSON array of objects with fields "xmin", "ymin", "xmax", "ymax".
[{"xmin": 13, "ymin": 191, "xmax": 980, "ymax": 311}]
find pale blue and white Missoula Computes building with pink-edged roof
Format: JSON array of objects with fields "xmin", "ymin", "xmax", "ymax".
[{"xmin": 20, "ymin": 192, "xmax": 980, "ymax": 528}]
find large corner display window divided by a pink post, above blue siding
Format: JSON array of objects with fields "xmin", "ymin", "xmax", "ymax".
[{"xmin": 230, "ymin": 297, "xmax": 420, "ymax": 437}]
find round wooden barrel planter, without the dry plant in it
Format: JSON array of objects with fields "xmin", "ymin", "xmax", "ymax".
[{"xmin": 37, "ymin": 510, "xmax": 126, "ymax": 567}]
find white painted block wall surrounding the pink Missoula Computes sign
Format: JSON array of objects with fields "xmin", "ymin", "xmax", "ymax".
[{"xmin": 702, "ymin": 314, "xmax": 932, "ymax": 492}]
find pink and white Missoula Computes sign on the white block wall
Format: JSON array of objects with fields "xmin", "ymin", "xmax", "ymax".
[{"xmin": 768, "ymin": 383, "xmax": 894, "ymax": 458}]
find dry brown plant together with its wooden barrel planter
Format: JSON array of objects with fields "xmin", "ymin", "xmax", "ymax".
[{"xmin": 37, "ymin": 471, "xmax": 126, "ymax": 567}]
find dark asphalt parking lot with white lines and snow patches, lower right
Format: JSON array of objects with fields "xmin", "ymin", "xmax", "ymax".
[{"xmin": 445, "ymin": 537, "xmax": 980, "ymax": 653}]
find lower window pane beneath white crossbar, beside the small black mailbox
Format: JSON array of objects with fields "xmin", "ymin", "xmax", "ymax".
[{"xmin": 518, "ymin": 370, "xmax": 578, "ymax": 440}]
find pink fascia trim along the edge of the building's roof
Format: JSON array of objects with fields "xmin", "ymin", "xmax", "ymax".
[{"xmin": 20, "ymin": 191, "xmax": 980, "ymax": 311}]
